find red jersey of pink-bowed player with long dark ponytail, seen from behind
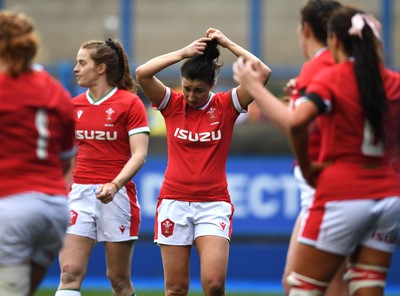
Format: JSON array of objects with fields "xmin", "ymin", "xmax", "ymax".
[{"xmin": 307, "ymin": 61, "xmax": 400, "ymax": 200}]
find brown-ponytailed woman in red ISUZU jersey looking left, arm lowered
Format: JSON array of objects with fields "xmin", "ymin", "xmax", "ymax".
[{"xmin": 56, "ymin": 39, "xmax": 150, "ymax": 296}]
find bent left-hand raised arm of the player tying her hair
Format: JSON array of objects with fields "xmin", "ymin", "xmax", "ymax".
[{"xmin": 136, "ymin": 37, "xmax": 210, "ymax": 106}]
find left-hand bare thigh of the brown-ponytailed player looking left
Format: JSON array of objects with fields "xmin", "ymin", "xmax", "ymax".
[{"xmin": 59, "ymin": 234, "xmax": 95, "ymax": 279}]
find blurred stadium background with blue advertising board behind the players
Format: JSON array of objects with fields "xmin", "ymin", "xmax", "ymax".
[{"xmin": 0, "ymin": 0, "xmax": 400, "ymax": 295}]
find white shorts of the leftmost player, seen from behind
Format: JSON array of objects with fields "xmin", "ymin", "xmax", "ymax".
[{"xmin": 0, "ymin": 192, "xmax": 68, "ymax": 268}]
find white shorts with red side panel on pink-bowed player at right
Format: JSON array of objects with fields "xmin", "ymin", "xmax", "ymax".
[{"xmin": 298, "ymin": 196, "xmax": 400, "ymax": 255}]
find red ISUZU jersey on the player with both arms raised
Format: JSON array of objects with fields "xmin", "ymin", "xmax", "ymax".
[{"xmin": 158, "ymin": 88, "xmax": 246, "ymax": 202}]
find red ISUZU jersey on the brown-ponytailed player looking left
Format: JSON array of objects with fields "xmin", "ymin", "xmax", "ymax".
[{"xmin": 72, "ymin": 87, "xmax": 150, "ymax": 184}]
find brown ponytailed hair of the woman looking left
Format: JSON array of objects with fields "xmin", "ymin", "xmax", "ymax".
[{"xmin": 81, "ymin": 39, "xmax": 137, "ymax": 93}]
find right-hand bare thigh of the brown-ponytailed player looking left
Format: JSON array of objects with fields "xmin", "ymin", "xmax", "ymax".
[{"xmin": 104, "ymin": 240, "xmax": 135, "ymax": 279}]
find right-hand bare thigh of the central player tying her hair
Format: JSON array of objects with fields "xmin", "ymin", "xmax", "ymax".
[{"xmin": 195, "ymin": 235, "xmax": 229, "ymax": 280}]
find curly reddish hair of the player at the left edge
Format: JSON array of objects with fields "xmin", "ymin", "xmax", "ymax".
[{"xmin": 0, "ymin": 11, "xmax": 39, "ymax": 77}]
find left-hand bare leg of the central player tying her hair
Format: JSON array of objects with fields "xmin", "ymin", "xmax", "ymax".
[{"xmin": 160, "ymin": 244, "xmax": 191, "ymax": 296}]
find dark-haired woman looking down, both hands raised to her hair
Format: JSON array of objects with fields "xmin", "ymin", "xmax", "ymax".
[{"xmin": 136, "ymin": 28, "xmax": 271, "ymax": 295}]
